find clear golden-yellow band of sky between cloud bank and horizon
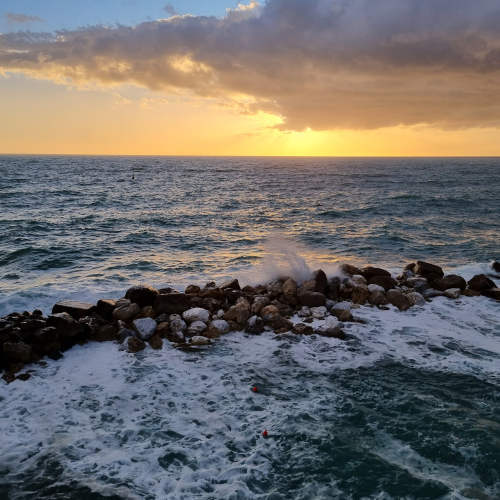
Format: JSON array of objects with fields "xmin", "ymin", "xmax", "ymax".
[{"xmin": 0, "ymin": 75, "xmax": 500, "ymax": 156}]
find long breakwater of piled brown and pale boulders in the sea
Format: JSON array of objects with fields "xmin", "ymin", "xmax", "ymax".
[{"xmin": 0, "ymin": 261, "xmax": 500, "ymax": 382}]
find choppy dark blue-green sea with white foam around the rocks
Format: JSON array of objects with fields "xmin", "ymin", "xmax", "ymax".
[{"xmin": 0, "ymin": 156, "xmax": 500, "ymax": 500}]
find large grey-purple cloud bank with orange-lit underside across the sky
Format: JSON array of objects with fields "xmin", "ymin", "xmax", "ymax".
[{"xmin": 0, "ymin": 0, "xmax": 500, "ymax": 130}]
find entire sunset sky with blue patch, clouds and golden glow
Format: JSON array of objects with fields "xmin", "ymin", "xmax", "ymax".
[{"xmin": 0, "ymin": 0, "xmax": 500, "ymax": 156}]
